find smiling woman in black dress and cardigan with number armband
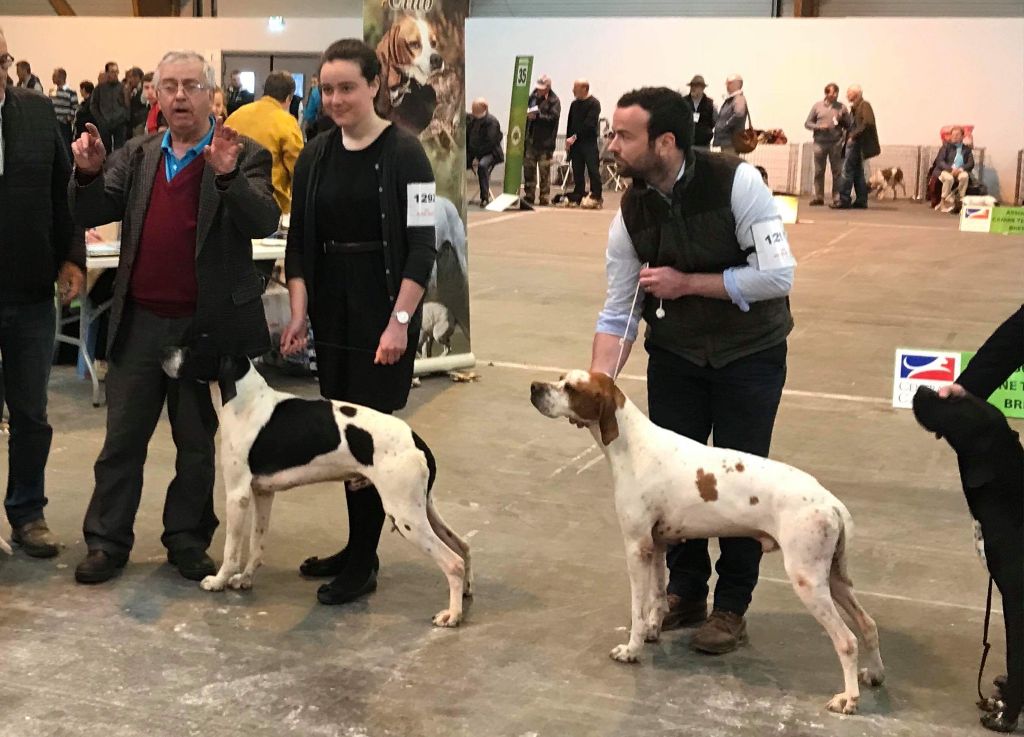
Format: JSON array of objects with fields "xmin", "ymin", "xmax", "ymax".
[{"xmin": 281, "ymin": 39, "xmax": 434, "ymax": 604}]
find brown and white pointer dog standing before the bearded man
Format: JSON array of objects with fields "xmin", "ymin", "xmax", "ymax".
[{"xmin": 530, "ymin": 371, "xmax": 885, "ymax": 713}]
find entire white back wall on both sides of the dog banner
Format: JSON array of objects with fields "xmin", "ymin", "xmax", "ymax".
[{"xmin": 0, "ymin": 15, "xmax": 1024, "ymax": 198}]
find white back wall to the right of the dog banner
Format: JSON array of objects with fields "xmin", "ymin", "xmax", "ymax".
[{"xmin": 466, "ymin": 18, "xmax": 1024, "ymax": 199}]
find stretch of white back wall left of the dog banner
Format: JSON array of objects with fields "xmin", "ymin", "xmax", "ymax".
[{"xmin": 0, "ymin": 15, "xmax": 362, "ymax": 89}]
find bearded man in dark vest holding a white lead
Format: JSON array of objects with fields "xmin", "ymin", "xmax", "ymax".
[{"xmin": 591, "ymin": 87, "xmax": 796, "ymax": 654}]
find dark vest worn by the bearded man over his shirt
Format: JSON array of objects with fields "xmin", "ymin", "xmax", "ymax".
[{"xmin": 622, "ymin": 150, "xmax": 793, "ymax": 369}]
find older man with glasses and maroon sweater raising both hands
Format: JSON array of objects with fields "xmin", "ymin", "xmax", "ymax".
[{"xmin": 69, "ymin": 51, "xmax": 280, "ymax": 583}]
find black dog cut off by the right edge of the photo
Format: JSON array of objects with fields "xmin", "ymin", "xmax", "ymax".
[{"xmin": 913, "ymin": 387, "xmax": 1024, "ymax": 732}]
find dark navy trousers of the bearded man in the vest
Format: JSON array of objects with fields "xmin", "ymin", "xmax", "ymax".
[{"xmin": 647, "ymin": 342, "xmax": 786, "ymax": 616}]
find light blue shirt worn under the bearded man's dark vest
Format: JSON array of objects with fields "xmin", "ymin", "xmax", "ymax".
[{"xmin": 597, "ymin": 158, "xmax": 795, "ymax": 341}]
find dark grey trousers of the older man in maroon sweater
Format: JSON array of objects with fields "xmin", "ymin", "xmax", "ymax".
[{"xmin": 83, "ymin": 304, "xmax": 217, "ymax": 556}]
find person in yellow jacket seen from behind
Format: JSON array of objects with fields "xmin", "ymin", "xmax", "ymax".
[{"xmin": 224, "ymin": 72, "xmax": 302, "ymax": 214}]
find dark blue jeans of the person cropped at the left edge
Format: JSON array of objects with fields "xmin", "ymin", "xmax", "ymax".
[{"xmin": 0, "ymin": 299, "xmax": 56, "ymax": 527}]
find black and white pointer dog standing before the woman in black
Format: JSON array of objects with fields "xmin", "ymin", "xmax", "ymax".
[{"xmin": 163, "ymin": 348, "xmax": 473, "ymax": 627}]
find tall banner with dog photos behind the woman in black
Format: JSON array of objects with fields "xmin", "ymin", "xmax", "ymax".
[{"xmin": 362, "ymin": 0, "xmax": 475, "ymax": 374}]
